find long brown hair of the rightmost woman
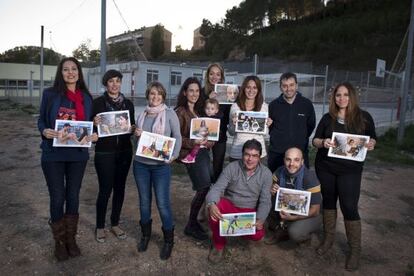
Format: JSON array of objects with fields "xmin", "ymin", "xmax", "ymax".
[{"xmin": 329, "ymin": 82, "xmax": 365, "ymax": 133}]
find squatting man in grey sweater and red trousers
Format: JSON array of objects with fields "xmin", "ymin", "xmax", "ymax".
[{"xmin": 206, "ymin": 139, "xmax": 272, "ymax": 263}]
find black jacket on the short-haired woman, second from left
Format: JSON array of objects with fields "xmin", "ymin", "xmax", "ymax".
[{"xmin": 92, "ymin": 96, "xmax": 135, "ymax": 152}]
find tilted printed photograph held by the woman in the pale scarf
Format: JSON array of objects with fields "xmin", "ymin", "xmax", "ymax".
[{"xmin": 136, "ymin": 131, "xmax": 175, "ymax": 161}]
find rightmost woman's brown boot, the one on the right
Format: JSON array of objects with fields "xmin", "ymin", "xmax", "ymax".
[{"xmin": 345, "ymin": 220, "xmax": 361, "ymax": 271}]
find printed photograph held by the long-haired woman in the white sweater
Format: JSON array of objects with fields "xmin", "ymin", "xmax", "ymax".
[{"xmin": 236, "ymin": 111, "xmax": 269, "ymax": 134}]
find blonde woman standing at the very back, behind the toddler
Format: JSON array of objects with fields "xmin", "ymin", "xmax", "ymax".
[{"xmin": 200, "ymin": 63, "xmax": 231, "ymax": 182}]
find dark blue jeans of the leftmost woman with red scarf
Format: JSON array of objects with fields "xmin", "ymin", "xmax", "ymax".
[{"xmin": 41, "ymin": 161, "xmax": 87, "ymax": 222}]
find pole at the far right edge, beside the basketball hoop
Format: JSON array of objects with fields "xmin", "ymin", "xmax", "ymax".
[{"xmin": 397, "ymin": 0, "xmax": 414, "ymax": 144}]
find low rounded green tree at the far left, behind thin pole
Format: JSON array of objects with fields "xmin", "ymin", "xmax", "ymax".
[{"xmin": 0, "ymin": 46, "xmax": 63, "ymax": 65}]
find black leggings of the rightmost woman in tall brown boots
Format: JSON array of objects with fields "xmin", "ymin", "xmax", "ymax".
[{"xmin": 316, "ymin": 168, "xmax": 362, "ymax": 220}]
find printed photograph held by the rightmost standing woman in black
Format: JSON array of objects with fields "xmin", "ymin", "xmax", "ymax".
[{"xmin": 328, "ymin": 132, "xmax": 369, "ymax": 162}]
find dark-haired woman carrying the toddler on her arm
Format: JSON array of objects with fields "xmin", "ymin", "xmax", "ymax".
[{"xmin": 175, "ymin": 78, "xmax": 214, "ymax": 240}]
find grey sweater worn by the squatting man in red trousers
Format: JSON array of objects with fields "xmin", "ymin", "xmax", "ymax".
[{"xmin": 206, "ymin": 160, "xmax": 272, "ymax": 222}]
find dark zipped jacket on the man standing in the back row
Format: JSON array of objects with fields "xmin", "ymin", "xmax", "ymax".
[{"xmin": 269, "ymin": 92, "xmax": 316, "ymax": 153}]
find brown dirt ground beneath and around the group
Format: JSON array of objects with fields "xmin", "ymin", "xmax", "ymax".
[{"xmin": 0, "ymin": 102, "xmax": 414, "ymax": 275}]
